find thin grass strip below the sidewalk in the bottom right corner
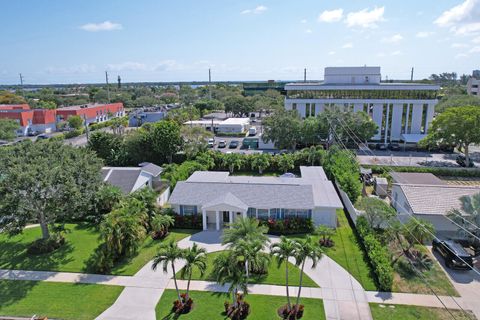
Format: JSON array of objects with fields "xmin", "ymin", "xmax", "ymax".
[{"xmin": 370, "ymin": 303, "xmax": 475, "ymax": 320}]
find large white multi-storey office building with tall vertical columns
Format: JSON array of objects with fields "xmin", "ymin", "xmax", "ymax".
[{"xmin": 285, "ymin": 67, "xmax": 440, "ymax": 143}]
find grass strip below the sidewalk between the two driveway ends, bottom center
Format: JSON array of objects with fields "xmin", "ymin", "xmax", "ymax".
[{"xmin": 156, "ymin": 290, "xmax": 325, "ymax": 320}]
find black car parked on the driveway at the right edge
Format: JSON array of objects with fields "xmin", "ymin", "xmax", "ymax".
[{"xmin": 432, "ymin": 239, "xmax": 473, "ymax": 270}]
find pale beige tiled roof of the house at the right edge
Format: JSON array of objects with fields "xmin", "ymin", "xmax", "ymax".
[{"xmin": 399, "ymin": 184, "xmax": 480, "ymax": 215}]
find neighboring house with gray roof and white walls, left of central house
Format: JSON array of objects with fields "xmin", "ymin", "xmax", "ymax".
[{"xmin": 102, "ymin": 162, "xmax": 170, "ymax": 205}]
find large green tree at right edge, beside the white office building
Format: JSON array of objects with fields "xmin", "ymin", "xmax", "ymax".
[{"xmin": 421, "ymin": 106, "xmax": 480, "ymax": 166}]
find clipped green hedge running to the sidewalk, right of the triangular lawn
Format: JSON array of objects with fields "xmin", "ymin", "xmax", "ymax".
[{"xmin": 356, "ymin": 217, "xmax": 393, "ymax": 291}]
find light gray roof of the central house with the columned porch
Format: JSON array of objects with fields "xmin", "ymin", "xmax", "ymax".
[{"xmin": 169, "ymin": 167, "xmax": 343, "ymax": 209}]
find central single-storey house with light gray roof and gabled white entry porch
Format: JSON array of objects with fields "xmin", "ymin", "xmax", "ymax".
[{"xmin": 169, "ymin": 167, "xmax": 343, "ymax": 230}]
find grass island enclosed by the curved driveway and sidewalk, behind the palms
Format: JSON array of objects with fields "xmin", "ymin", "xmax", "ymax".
[{"xmin": 177, "ymin": 251, "xmax": 318, "ymax": 287}]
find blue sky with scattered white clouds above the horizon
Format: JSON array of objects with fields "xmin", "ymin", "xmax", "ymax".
[{"xmin": 0, "ymin": 0, "xmax": 480, "ymax": 84}]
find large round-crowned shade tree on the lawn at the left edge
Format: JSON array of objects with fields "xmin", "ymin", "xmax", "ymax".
[{"xmin": 0, "ymin": 141, "xmax": 102, "ymax": 239}]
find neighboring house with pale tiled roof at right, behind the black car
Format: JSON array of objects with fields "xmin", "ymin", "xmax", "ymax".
[{"xmin": 392, "ymin": 173, "xmax": 480, "ymax": 235}]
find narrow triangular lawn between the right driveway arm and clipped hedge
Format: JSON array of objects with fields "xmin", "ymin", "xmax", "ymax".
[{"xmin": 291, "ymin": 210, "xmax": 376, "ymax": 291}]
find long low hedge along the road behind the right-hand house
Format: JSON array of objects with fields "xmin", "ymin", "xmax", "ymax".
[{"xmin": 364, "ymin": 165, "xmax": 480, "ymax": 177}]
